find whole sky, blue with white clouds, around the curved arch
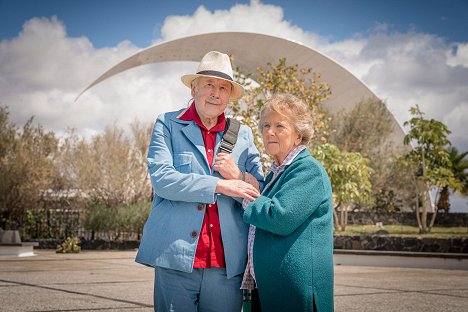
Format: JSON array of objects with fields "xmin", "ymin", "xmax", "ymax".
[{"xmin": 0, "ymin": 0, "xmax": 468, "ymax": 210}]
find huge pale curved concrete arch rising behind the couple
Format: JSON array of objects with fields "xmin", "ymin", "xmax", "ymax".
[{"xmin": 77, "ymin": 32, "xmax": 405, "ymax": 146}]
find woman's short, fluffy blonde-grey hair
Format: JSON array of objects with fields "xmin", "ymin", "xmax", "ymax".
[{"xmin": 258, "ymin": 94, "xmax": 314, "ymax": 145}]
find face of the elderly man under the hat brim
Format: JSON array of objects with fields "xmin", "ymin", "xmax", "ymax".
[{"xmin": 192, "ymin": 77, "xmax": 232, "ymax": 121}]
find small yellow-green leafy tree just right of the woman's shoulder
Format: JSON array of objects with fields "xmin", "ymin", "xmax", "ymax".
[{"xmin": 312, "ymin": 144, "xmax": 373, "ymax": 231}]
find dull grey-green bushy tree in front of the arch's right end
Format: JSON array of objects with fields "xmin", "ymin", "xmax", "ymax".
[{"xmin": 330, "ymin": 98, "xmax": 415, "ymax": 211}]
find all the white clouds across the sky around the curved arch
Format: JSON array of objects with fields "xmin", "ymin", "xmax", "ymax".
[{"xmin": 0, "ymin": 0, "xmax": 468, "ymax": 155}]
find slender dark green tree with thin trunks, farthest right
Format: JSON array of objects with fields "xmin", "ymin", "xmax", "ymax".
[{"xmin": 402, "ymin": 105, "xmax": 461, "ymax": 234}]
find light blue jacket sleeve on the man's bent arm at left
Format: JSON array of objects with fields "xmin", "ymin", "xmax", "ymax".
[{"xmin": 148, "ymin": 114, "xmax": 219, "ymax": 203}]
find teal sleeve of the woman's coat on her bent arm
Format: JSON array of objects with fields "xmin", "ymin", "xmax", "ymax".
[{"xmin": 244, "ymin": 162, "xmax": 327, "ymax": 236}]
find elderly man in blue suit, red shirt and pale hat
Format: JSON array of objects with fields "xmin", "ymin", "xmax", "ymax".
[{"xmin": 136, "ymin": 51, "xmax": 263, "ymax": 312}]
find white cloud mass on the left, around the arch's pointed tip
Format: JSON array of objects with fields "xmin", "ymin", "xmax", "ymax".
[{"xmin": 0, "ymin": 17, "xmax": 189, "ymax": 136}]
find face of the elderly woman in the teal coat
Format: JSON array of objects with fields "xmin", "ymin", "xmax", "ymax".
[{"xmin": 262, "ymin": 111, "xmax": 302, "ymax": 164}]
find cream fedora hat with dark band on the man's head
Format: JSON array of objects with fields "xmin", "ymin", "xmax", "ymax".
[{"xmin": 181, "ymin": 51, "xmax": 244, "ymax": 100}]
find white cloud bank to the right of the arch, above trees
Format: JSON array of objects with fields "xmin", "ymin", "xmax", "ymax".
[{"xmin": 321, "ymin": 31, "xmax": 468, "ymax": 150}]
